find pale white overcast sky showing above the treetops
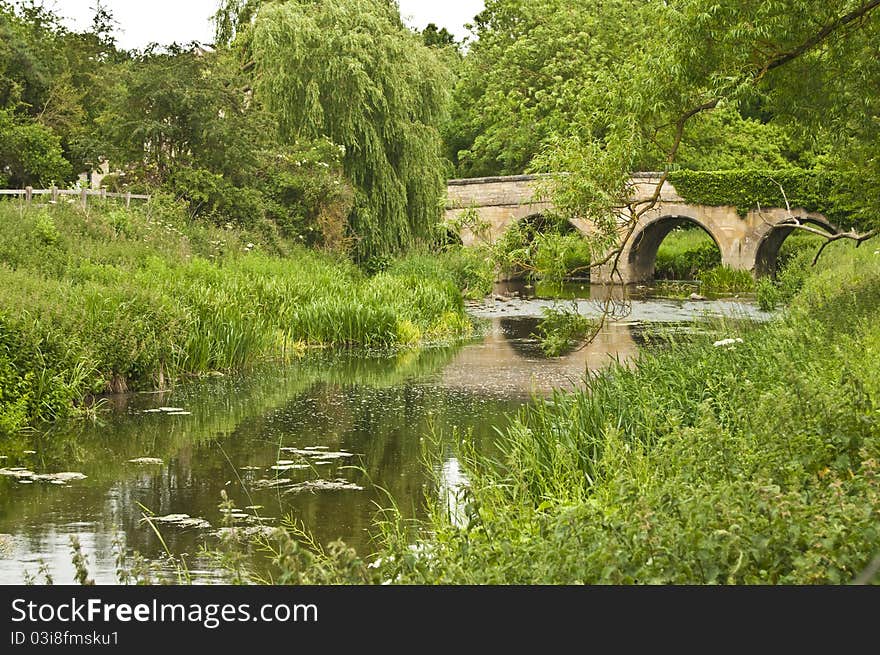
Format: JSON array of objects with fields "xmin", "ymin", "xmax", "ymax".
[{"xmin": 51, "ymin": 0, "xmax": 483, "ymax": 49}]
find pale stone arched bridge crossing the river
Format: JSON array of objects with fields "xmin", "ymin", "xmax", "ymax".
[{"xmin": 446, "ymin": 173, "xmax": 833, "ymax": 283}]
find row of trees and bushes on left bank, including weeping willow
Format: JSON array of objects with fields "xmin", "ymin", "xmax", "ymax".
[{"xmin": 0, "ymin": 0, "xmax": 460, "ymax": 261}]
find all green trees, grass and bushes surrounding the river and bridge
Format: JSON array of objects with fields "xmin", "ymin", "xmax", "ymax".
[{"xmin": 0, "ymin": 0, "xmax": 880, "ymax": 583}]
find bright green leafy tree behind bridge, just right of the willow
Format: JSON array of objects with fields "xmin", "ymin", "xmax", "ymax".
[{"xmin": 445, "ymin": 0, "xmax": 639, "ymax": 177}]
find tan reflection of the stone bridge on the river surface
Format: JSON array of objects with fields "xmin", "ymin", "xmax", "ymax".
[{"xmin": 442, "ymin": 318, "xmax": 638, "ymax": 398}]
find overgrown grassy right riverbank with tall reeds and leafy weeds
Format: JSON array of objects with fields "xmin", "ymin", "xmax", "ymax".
[{"xmin": 320, "ymin": 247, "xmax": 880, "ymax": 584}]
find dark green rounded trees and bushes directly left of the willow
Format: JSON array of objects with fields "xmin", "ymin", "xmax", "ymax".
[{"xmin": 100, "ymin": 39, "xmax": 352, "ymax": 253}]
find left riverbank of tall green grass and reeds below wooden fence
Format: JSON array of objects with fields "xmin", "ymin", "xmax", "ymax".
[{"xmin": 0, "ymin": 201, "xmax": 482, "ymax": 434}]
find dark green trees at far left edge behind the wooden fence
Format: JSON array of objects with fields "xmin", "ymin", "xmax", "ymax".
[{"xmin": 0, "ymin": 1, "xmax": 117, "ymax": 187}]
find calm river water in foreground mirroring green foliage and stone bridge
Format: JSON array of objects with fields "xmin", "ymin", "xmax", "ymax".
[{"xmin": 0, "ymin": 302, "xmax": 748, "ymax": 584}]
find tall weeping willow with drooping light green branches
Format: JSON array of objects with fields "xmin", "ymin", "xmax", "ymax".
[{"xmin": 217, "ymin": 0, "xmax": 451, "ymax": 260}]
